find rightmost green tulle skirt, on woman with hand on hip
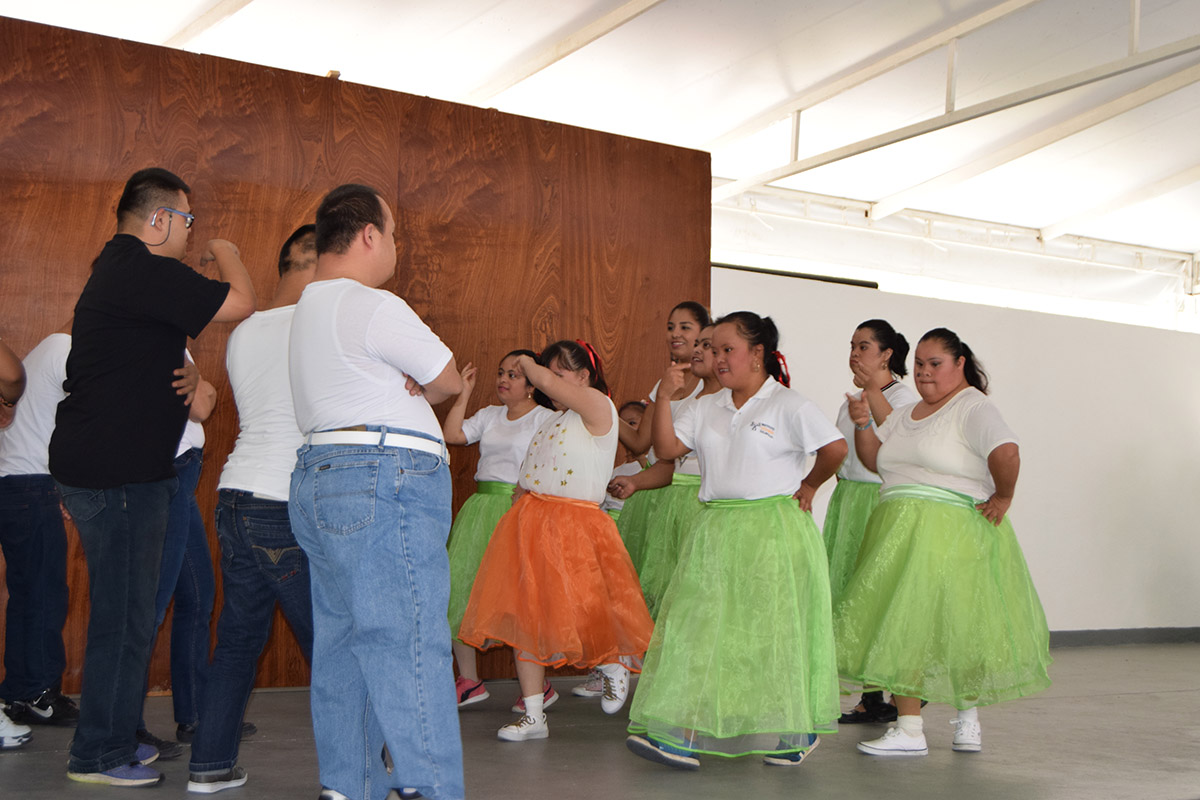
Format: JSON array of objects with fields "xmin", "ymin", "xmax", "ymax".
[{"xmin": 834, "ymin": 486, "xmax": 1050, "ymax": 709}]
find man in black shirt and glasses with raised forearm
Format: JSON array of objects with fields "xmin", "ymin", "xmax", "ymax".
[{"xmin": 50, "ymin": 168, "xmax": 256, "ymax": 786}]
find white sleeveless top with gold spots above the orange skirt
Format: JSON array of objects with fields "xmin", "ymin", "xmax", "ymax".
[{"xmin": 518, "ymin": 401, "xmax": 617, "ymax": 505}]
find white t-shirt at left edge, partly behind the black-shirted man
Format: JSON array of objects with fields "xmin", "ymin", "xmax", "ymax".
[{"xmin": 0, "ymin": 333, "xmax": 71, "ymax": 476}]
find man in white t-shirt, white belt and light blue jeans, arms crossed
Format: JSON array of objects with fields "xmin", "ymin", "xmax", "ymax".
[{"xmin": 288, "ymin": 184, "xmax": 463, "ymax": 800}]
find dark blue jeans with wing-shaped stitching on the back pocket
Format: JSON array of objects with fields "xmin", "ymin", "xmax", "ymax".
[{"xmin": 190, "ymin": 489, "xmax": 312, "ymax": 772}]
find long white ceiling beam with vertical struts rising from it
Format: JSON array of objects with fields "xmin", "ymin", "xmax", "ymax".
[{"xmin": 713, "ymin": 36, "xmax": 1200, "ymax": 203}]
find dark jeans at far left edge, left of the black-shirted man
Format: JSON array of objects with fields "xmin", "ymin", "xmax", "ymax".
[{"xmin": 0, "ymin": 475, "xmax": 67, "ymax": 700}]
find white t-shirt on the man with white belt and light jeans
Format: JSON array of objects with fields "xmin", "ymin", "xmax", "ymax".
[{"xmin": 288, "ymin": 278, "xmax": 452, "ymax": 441}]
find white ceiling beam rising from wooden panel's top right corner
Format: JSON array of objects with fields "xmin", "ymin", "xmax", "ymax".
[{"xmin": 701, "ymin": 0, "xmax": 1039, "ymax": 152}]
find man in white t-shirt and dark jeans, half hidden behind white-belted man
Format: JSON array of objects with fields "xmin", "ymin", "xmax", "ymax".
[{"xmin": 187, "ymin": 224, "xmax": 317, "ymax": 794}]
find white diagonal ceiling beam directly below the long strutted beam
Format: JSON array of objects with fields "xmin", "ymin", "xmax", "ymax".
[{"xmin": 870, "ymin": 56, "xmax": 1200, "ymax": 219}]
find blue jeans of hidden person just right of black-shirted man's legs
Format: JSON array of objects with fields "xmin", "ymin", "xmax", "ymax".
[{"xmin": 142, "ymin": 447, "xmax": 216, "ymax": 727}]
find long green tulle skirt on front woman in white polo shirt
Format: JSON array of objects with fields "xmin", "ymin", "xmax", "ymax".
[{"xmin": 629, "ymin": 497, "xmax": 839, "ymax": 756}]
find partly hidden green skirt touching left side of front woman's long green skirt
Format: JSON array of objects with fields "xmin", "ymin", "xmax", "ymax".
[{"xmin": 634, "ymin": 475, "xmax": 704, "ymax": 619}]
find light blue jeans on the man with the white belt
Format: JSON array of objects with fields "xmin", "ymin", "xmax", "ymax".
[{"xmin": 288, "ymin": 431, "xmax": 463, "ymax": 800}]
